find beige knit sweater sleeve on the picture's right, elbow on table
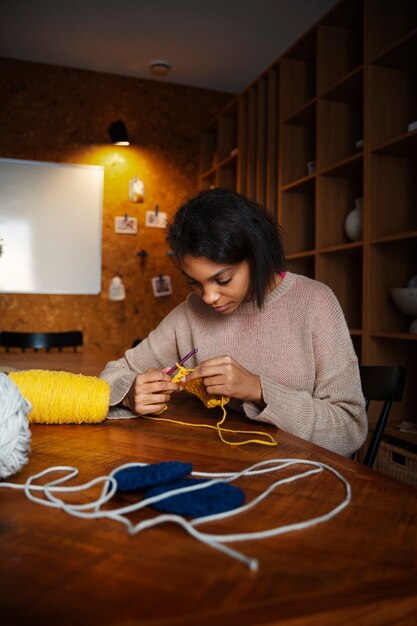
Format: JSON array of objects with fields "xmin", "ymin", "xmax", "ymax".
[{"xmin": 243, "ymin": 289, "xmax": 367, "ymax": 456}]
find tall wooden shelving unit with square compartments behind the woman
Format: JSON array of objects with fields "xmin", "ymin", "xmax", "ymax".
[{"xmin": 197, "ymin": 0, "xmax": 417, "ymax": 466}]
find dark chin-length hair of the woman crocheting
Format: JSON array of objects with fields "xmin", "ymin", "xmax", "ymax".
[{"xmin": 167, "ymin": 187, "xmax": 285, "ymax": 308}]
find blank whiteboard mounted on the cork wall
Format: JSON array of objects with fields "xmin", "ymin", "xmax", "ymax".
[{"xmin": 0, "ymin": 159, "xmax": 104, "ymax": 294}]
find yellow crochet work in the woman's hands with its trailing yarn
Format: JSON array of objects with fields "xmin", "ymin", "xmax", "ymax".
[{"xmin": 147, "ymin": 363, "xmax": 278, "ymax": 446}]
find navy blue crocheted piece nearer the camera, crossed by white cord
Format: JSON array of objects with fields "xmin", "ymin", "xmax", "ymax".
[{"xmin": 144, "ymin": 478, "xmax": 245, "ymax": 518}]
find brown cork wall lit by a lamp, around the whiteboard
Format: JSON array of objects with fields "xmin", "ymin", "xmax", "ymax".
[{"xmin": 0, "ymin": 59, "xmax": 231, "ymax": 356}]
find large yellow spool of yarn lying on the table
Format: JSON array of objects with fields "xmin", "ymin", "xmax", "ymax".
[{"xmin": 9, "ymin": 370, "xmax": 110, "ymax": 424}]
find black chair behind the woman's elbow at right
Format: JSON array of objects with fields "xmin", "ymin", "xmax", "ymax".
[{"xmin": 359, "ymin": 365, "xmax": 407, "ymax": 467}]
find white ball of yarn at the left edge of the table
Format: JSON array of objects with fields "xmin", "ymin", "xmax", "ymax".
[{"xmin": 0, "ymin": 374, "xmax": 32, "ymax": 479}]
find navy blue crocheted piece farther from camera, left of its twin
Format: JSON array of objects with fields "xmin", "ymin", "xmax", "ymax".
[{"xmin": 113, "ymin": 461, "xmax": 193, "ymax": 491}]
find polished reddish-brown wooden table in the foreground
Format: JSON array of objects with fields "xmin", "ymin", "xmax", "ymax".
[{"xmin": 0, "ymin": 355, "xmax": 417, "ymax": 626}]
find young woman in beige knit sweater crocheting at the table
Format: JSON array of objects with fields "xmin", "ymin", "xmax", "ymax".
[{"xmin": 101, "ymin": 188, "xmax": 367, "ymax": 456}]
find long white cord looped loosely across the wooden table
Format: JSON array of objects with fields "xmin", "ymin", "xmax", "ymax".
[{"xmin": 0, "ymin": 459, "xmax": 352, "ymax": 571}]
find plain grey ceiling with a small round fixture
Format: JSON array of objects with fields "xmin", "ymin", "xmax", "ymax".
[{"xmin": 0, "ymin": 0, "xmax": 335, "ymax": 93}]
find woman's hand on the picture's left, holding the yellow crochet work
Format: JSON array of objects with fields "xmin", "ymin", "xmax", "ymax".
[{"xmin": 121, "ymin": 368, "xmax": 181, "ymax": 415}]
